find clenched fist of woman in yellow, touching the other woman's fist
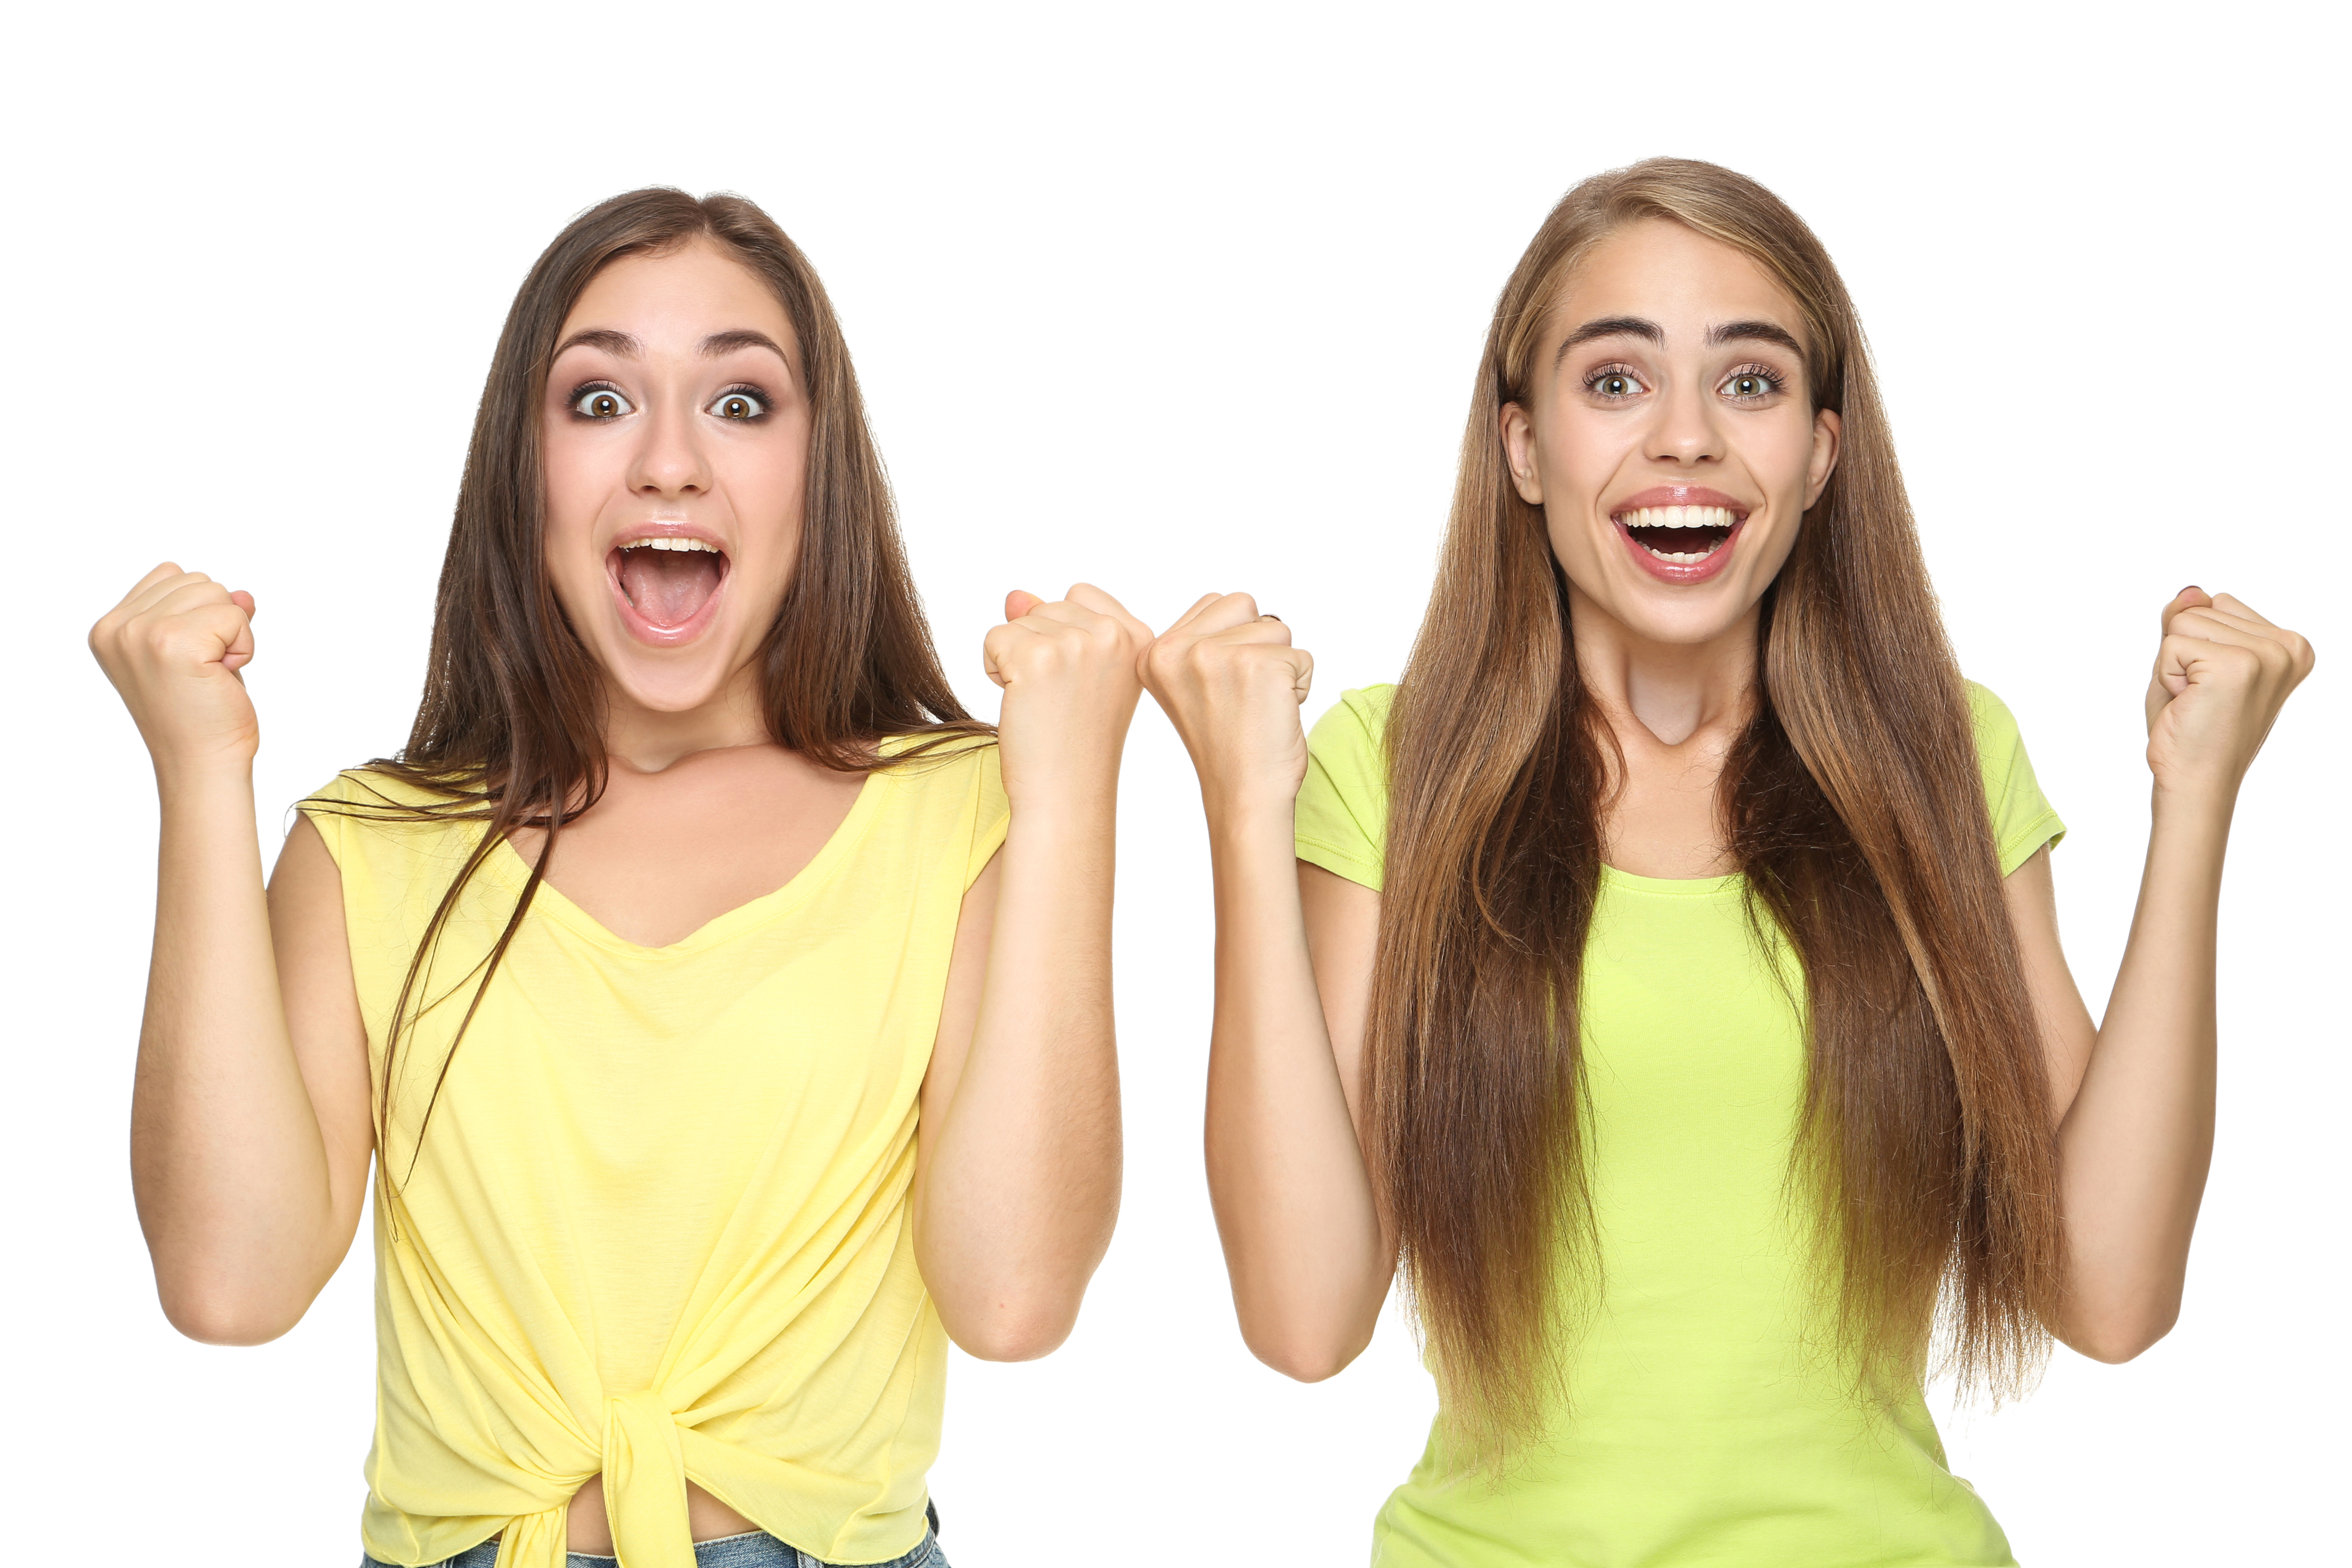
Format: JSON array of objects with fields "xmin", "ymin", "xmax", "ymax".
[{"xmin": 981, "ymin": 583, "xmax": 1152, "ymax": 806}]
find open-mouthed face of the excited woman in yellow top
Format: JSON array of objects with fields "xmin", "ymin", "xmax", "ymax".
[{"xmin": 541, "ymin": 240, "xmax": 809, "ymax": 712}]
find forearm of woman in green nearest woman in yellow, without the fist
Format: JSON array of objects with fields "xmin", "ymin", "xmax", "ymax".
[{"xmin": 1207, "ymin": 802, "xmax": 1395, "ymax": 1380}]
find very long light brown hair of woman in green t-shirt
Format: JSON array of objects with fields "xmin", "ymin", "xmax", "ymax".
[{"xmin": 1366, "ymin": 157, "xmax": 2063, "ymax": 1462}]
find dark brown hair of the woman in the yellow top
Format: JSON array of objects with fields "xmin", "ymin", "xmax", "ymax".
[{"xmin": 310, "ymin": 188, "xmax": 988, "ymax": 1197}]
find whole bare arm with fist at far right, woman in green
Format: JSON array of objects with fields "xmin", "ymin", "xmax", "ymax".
[{"xmin": 2006, "ymin": 590, "xmax": 2312, "ymax": 1361}]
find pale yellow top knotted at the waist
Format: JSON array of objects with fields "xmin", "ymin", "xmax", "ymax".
[{"xmin": 306, "ymin": 743, "xmax": 1007, "ymax": 1568}]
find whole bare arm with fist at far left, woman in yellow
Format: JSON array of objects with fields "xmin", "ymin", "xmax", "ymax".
[{"xmin": 89, "ymin": 567, "xmax": 372, "ymax": 1344}]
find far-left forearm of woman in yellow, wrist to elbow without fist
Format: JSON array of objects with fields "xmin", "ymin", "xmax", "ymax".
[{"xmin": 132, "ymin": 769, "xmax": 336, "ymax": 1340}]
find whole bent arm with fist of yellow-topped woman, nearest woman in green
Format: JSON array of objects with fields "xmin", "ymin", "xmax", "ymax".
[{"xmin": 915, "ymin": 585, "xmax": 1150, "ymax": 1361}]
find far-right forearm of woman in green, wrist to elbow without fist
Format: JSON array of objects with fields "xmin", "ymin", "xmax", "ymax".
[{"xmin": 2058, "ymin": 792, "xmax": 2230, "ymax": 1361}]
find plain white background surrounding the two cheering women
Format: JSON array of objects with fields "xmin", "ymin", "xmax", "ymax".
[{"xmin": 0, "ymin": 0, "xmax": 2352, "ymax": 1568}]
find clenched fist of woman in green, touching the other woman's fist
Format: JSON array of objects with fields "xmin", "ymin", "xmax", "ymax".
[{"xmin": 1143, "ymin": 592, "xmax": 1315, "ymax": 813}]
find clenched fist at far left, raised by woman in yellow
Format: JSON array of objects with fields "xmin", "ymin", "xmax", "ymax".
[{"xmin": 89, "ymin": 562, "xmax": 261, "ymax": 773}]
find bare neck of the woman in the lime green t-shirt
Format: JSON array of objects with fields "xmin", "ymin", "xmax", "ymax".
[{"xmin": 1569, "ymin": 583, "xmax": 1764, "ymax": 747}]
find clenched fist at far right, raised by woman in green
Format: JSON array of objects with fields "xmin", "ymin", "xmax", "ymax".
[{"xmin": 2147, "ymin": 588, "xmax": 2312, "ymax": 799}]
